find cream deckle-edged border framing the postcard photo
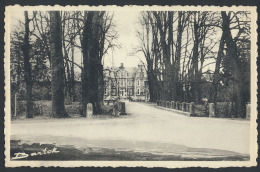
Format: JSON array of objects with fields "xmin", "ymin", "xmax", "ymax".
[{"xmin": 4, "ymin": 5, "xmax": 258, "ymax": 168}]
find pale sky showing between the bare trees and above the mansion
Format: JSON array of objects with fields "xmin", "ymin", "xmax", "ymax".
[{"xmin": 11, "ymin": 10, "xmax": 144, "ymax": 70}]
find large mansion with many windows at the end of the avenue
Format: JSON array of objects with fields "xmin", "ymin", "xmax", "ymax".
[{"xmin": 104, "ymin": 63, "xmax": 149, "ymax": 101}]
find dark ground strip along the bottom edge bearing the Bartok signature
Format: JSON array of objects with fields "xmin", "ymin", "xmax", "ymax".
[{"xmin": 10, "ymin": 140, "xmax": 249, "ymax": 161}]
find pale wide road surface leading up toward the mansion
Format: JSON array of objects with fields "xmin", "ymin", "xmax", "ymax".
[{"xmin": 11, "ymin": 102, "xmax": 250, "ymax": 160}]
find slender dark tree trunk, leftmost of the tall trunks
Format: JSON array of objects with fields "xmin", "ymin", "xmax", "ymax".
[{"xmin": 22, "ymin": 11, "xmax": 33, "ymax": 118}]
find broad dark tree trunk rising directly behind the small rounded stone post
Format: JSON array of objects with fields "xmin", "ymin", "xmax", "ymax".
[{"xmin": 81, "ymin": 11, "xmax": 116, "ymax": 116}]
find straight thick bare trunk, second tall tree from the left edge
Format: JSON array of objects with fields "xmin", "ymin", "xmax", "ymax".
[{"xmin": 50, "ymin": 11, "xmax": 67, "ymax": 117}]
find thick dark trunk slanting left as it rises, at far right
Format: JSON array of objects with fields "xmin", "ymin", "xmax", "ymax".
[{"xmin": 221, "ymin": 11, "xmax": 246, "ymax": 118}]
